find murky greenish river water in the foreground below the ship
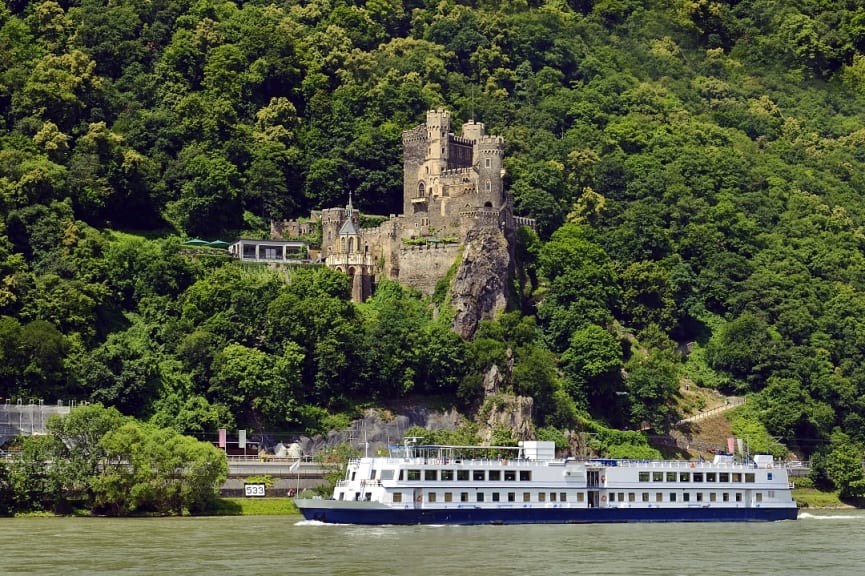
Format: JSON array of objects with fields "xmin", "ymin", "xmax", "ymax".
[{"xmin": 0, "ymin": 511, "xmax": 865, "ymax": 576}]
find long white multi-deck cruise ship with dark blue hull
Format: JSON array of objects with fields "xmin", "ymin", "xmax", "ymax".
[{"xmin": 296, "ymin": 438, "xmax": 797, "ymax": 524}]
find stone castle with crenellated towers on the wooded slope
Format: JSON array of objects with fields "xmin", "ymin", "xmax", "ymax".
[{"xmin": 272, "ymin": 110, "xmax": 534, "ymax": 301}]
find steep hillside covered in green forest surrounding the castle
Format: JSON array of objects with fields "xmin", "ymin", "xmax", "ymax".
[{"xmin": 0, "ymin": 0, "xmax": 865, "ymax": 486}]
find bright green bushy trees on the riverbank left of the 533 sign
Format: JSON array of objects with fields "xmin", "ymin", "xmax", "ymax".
[{"xmin": 0, "ymin": 404, "xmax": 228, "ymax": 516}]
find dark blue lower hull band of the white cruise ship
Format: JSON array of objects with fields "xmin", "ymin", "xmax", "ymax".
[{"xmin": 301, "ymin": 507, "xmax": 797, "ymax": 525}]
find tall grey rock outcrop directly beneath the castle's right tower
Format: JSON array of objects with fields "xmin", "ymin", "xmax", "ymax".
[{"xmin": 451, "ymin": 227, "xmax": 513, "ymax": 339}]
